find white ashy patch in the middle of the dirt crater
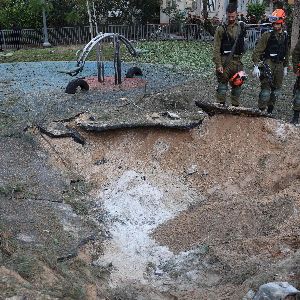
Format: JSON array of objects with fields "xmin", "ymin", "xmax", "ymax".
[{"xmin": 95, "ymin": 170, "xmax": 202, "ymax": 286}]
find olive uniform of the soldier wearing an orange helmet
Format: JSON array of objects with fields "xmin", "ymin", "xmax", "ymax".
[{"xmin": 252, "ymin": 30, "xmax": 289, "ymax": 110}]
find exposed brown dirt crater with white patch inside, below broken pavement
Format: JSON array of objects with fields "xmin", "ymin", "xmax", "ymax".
[{"xmin": 36, "ymin": 115, "xmax": 300, "ymax": 299}]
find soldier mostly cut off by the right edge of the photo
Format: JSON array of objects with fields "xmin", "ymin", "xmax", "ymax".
[{"xmin": 292, "ymin": 39, "xmax": 300, "ymax": 124}]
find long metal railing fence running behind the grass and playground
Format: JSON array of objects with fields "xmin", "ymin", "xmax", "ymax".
[{"xmin": 0, "ymin": 24, "xmax": 261, "ymax": 49}]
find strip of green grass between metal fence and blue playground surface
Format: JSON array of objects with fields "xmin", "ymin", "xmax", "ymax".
[{"xmin": 0, "ymin": 41, "xmax": 252, "ymax": 77}]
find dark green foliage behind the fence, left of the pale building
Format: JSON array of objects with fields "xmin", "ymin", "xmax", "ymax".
[{"xmin": 0, "ymin": 0, "xmax": 160, "ymax": 29}]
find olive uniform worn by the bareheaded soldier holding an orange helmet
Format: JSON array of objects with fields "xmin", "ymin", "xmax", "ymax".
[{"xmin": 213, "ymin": 21, "xmax": 244, "ymax": 106}]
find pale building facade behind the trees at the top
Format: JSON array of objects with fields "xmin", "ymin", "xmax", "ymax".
[{"xmin": 160, "ymin": 0, "xmax": 263, "ymax": 24}]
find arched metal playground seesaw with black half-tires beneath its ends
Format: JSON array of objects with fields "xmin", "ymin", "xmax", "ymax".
[{"xmin": 64, "ymin": 33, "xmax": 143, "ymax": 94}]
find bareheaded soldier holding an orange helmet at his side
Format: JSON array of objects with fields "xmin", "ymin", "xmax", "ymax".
[{"xmin": 213, "ymin": 3, "xmax": 246, "ymax": 106}]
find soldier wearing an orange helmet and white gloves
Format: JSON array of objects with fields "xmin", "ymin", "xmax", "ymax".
[{"xmin": 252, "ymin": 9, "xmax": 289, "ymax": 114}]
